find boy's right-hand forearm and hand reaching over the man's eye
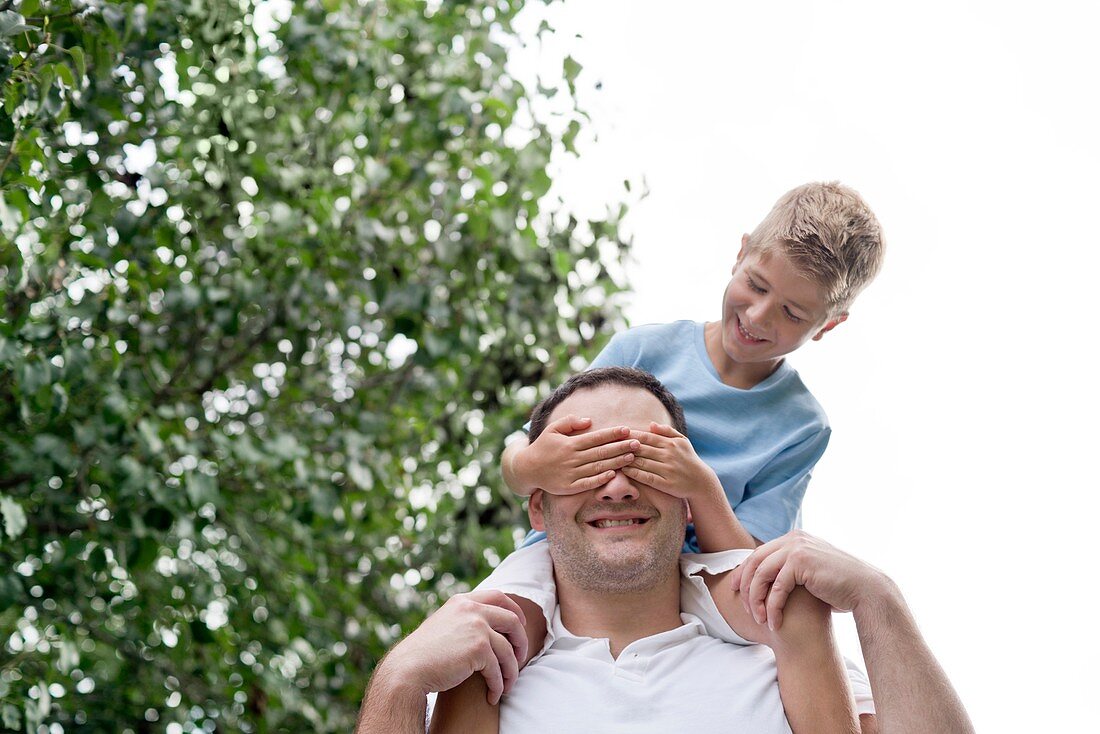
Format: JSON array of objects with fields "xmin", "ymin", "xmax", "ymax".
[{"xmin": 623, "ymin": 423, "xmax": 759, "ymax": 554}]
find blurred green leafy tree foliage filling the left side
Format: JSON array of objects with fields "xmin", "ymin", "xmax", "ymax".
[{"xmin": 0, "ymin": 0, "xmax": 627, "ymax": 732}]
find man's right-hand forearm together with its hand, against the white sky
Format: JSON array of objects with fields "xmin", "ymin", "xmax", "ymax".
[{"xmin": 729, "ymin": 530, "xmax": 974, "ymax": 734}]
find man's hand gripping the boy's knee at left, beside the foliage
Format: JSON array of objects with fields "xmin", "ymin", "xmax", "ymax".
[{"xmin": 380, "ymin": 591, "xmax": 527, "ymax": 704}]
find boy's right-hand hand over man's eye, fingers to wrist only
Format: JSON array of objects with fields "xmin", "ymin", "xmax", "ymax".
[{"xmin": 623, "ymin": 423, "xmax": 722, "ymax": 503}]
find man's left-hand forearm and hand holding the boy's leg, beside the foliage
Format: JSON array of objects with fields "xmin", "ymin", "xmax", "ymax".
[{"xmin": 355, "ymin": 591, "xmax": 527, "ymax": 734}]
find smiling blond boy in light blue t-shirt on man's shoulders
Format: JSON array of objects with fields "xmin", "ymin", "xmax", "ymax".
[{"xmin": 429, "ymin": 183, "xmax": 883, "ymax": 730}]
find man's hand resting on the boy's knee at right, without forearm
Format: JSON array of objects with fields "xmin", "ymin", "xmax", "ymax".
[{"xmin": 729, "ymin": 530, "xmax": 893, "ymax": 629}]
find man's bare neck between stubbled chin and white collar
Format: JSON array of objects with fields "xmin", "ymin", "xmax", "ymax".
[{"xmin": 558, "ymin": 572, "xmax": 682, "ymax": 658}]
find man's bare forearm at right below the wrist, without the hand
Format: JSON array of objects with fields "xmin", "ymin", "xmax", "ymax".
[{"xmin": 854, "ymin": 582, "xmax": 974, "ymax": 734}]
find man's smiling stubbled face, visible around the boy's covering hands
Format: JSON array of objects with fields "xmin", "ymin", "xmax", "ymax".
[{"xmin": 529, "ymin": 385, "xmax": 688, "ymax": 592}]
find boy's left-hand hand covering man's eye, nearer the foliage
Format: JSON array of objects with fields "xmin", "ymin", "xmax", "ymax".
[{"xmin": 513, "ymin": 415, "xmax": 641, "ymax": 494}]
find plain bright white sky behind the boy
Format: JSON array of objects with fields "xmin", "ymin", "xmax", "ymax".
[{"xmin": 513, "ymin": 0, "xmax": 1100, "ymax": 732}]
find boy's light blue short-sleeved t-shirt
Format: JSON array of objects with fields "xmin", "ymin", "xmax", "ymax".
[{"xmin": 524, "ymin": 321, "xmax": 829, "ymax": 552}]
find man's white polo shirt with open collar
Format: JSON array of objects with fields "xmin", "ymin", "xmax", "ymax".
[{"xmin": 492, "ymin": 544, "xmax": 875, "ymax": 734}]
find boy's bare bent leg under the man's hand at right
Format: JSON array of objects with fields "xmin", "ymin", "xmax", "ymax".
[{"xmin": 703, "ymin": 572, "xmax": 866, "ymax": 734}]
